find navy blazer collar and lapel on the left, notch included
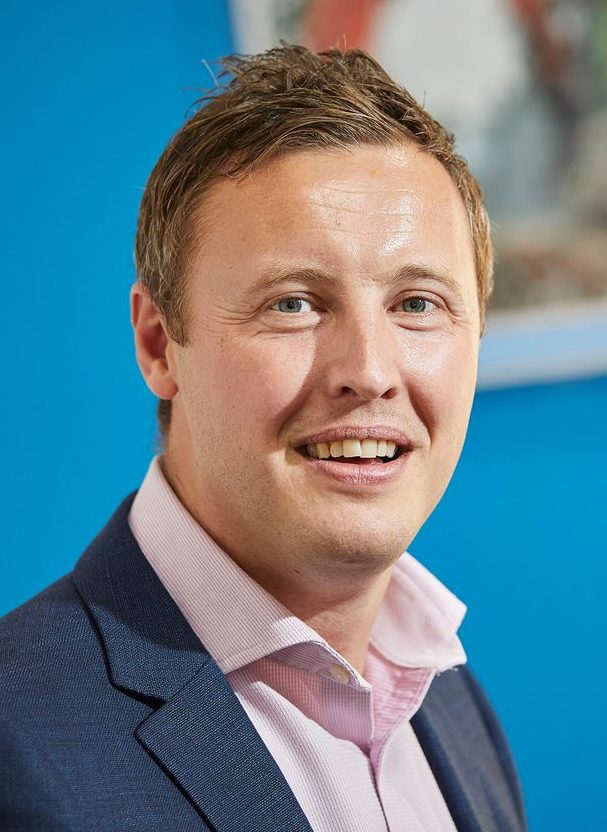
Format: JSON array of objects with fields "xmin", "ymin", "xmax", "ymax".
[{"xmin": 74, "ymin": 495, "xmax": 312, "ymax": 832}]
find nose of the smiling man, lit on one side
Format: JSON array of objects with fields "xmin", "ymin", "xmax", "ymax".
[{"xmin": 327, "ymin": 309, "xmax": 403, "ymax": 401}]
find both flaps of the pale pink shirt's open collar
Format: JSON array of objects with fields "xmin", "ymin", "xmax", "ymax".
[{"xmin": 129, "ymin": 457, "xmax": 466, "ymax": 673}]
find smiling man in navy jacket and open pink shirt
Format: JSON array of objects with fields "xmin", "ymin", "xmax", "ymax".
[{"xmin": 0, "ymin": 46, "xmax": 524, "ymax": 832}]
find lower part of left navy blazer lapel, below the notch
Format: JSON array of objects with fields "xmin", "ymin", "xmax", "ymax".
[{"xmin": 137, "ymin": 661, "xmax": 311, "ymax": 832}]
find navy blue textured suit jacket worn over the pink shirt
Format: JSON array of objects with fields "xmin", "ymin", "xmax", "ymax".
[{"xmin": 0, "ymin": 495, "xmax": 525, "ymax": 832}]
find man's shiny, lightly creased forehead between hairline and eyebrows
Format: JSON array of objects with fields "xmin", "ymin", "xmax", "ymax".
[{"xmin": 192, "ymin": 143, "xmax": 474, "ymax": 292}]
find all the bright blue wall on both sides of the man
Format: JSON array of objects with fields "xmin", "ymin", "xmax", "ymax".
[{"xmin": 0, "ymin": 0, "xmax": 607, "ymax": 832}]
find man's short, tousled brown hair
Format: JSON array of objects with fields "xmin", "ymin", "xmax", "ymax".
[{"xmin": 135, "ymin": 44, "xmax": 493, "ymax": 436}]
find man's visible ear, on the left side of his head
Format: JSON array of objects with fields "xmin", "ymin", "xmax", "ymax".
[{"xmin": 131, "ymin": 283, "xmax": 179, "ymax": 399}]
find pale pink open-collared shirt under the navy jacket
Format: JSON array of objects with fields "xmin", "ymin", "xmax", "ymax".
[{"xmin": 129, "ymin": 458, "xmax": 466, "ymax": 832}]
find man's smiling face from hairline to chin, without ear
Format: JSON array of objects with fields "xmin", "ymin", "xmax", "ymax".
[{"xmin": 166, "ymin": 144, "xmax": 479, "ymax": 575}]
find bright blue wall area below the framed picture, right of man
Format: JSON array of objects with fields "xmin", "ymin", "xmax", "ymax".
[{"xmin": 411, "ymin": 377, "xmax": 607, "ymax": 832}]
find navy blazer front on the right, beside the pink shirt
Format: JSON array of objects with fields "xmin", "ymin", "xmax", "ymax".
[{"xmin": 411, "ymin": 668, "xmax": 525, "ymax": 832}]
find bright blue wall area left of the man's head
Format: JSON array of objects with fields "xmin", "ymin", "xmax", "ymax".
[{"xmin": 0, "ymin": 0, "xmax": 231, "ymax": 600}]
